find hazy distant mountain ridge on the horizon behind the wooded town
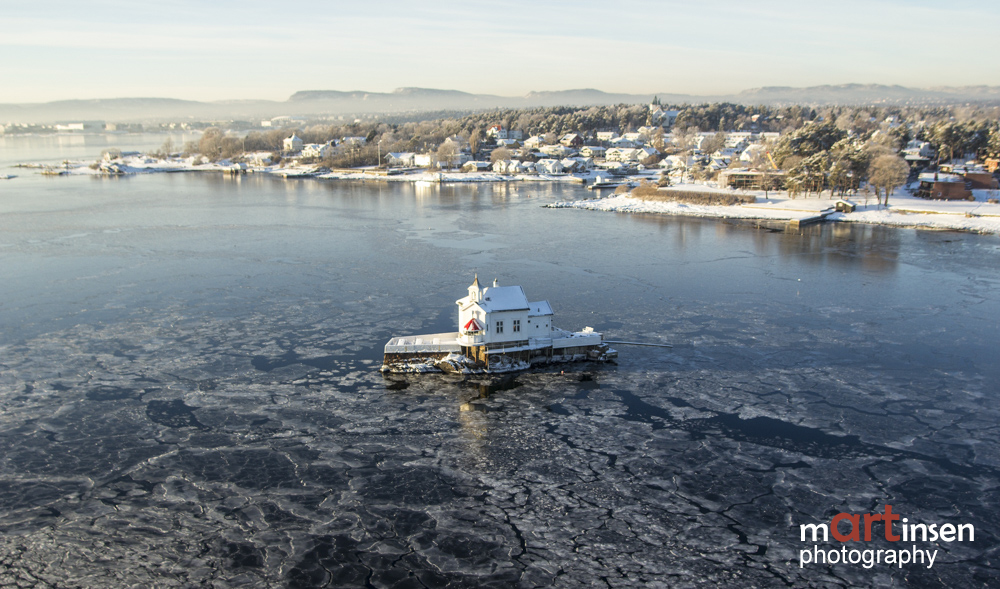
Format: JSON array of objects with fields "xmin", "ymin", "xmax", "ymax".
[{"xmin": 0, "ymin": 84, "xmax": 1000, "ymax": 123}]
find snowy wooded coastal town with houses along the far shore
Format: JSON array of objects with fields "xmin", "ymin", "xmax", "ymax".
[{"xmin": 5, "ymin": 98, "xmax": 1000, "ymax": 233}]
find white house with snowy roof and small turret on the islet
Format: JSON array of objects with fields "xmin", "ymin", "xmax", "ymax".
[{"xmin": 455, "ymin": 276, "xmax": 552, "ymax": 346}]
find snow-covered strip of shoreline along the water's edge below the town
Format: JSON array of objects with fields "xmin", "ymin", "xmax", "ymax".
[{"xmin": 21, "ymin": 155, "xmax": 1000, "ymax": 233}]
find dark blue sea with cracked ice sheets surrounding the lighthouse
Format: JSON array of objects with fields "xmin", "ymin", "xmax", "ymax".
[{"xmin": 0, "ymin": 138, "xmax": 1000, "ymax": 588}]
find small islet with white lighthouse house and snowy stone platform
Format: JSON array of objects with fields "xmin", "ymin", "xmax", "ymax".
[{"xmin": 381, "ymin": 276, "xmax": 618, "ymax": 373}]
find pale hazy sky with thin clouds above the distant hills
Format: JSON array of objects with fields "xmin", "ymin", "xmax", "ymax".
[{"xmin": 0, "ymin": 0, "xmax": 1000, "ymax": 103}]
